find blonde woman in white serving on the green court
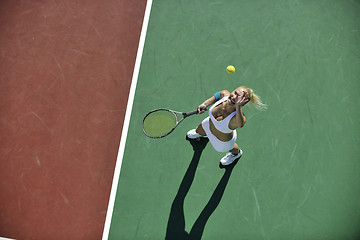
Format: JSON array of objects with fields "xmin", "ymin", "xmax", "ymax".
[{"xmin": 186, "ymin": 86, "xmax": 266, "ymax": 165}]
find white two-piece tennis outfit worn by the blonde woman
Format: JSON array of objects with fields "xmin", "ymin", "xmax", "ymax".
[{"xmin": 201, "ymin": 97, "xmax": 237, "ymax": 152}]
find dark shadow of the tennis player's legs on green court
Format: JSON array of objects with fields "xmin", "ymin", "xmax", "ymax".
[{"xmin": 165, "ymin": 138, "xmax": 239, "ymax": 240}]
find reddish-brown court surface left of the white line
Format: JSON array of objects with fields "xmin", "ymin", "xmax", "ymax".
[{"xmin": 0, "ymin": 0, "xmax": 146, "ymax": 239}]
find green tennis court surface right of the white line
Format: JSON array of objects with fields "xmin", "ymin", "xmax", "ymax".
[{"xmin": 109, "ymin": 0, "xmax": 360, "ymax": 240}]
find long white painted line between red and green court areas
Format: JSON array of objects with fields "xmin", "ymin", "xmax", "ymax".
[{"xmin": 102, "ymin": 0, "xmax": 152, "ymax": 240}]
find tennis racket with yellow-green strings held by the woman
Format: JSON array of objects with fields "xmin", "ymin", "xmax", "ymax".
[{"xmin": 142, "ymin": 108, "xmax": 206, "ymax": 138}]
